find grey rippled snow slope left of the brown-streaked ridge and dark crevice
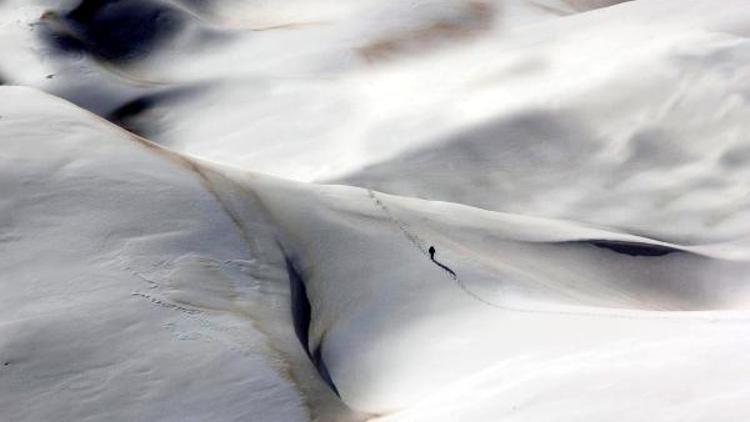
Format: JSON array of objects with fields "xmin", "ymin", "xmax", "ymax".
[{"xmin": 0, "ymin": 88, "xmax": 350, "ymax": 421}]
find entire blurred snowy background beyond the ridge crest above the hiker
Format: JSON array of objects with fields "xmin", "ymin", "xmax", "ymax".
[{"xmin": 0, "ymin": 0, "xmax": 750, "ymax": 244}]
